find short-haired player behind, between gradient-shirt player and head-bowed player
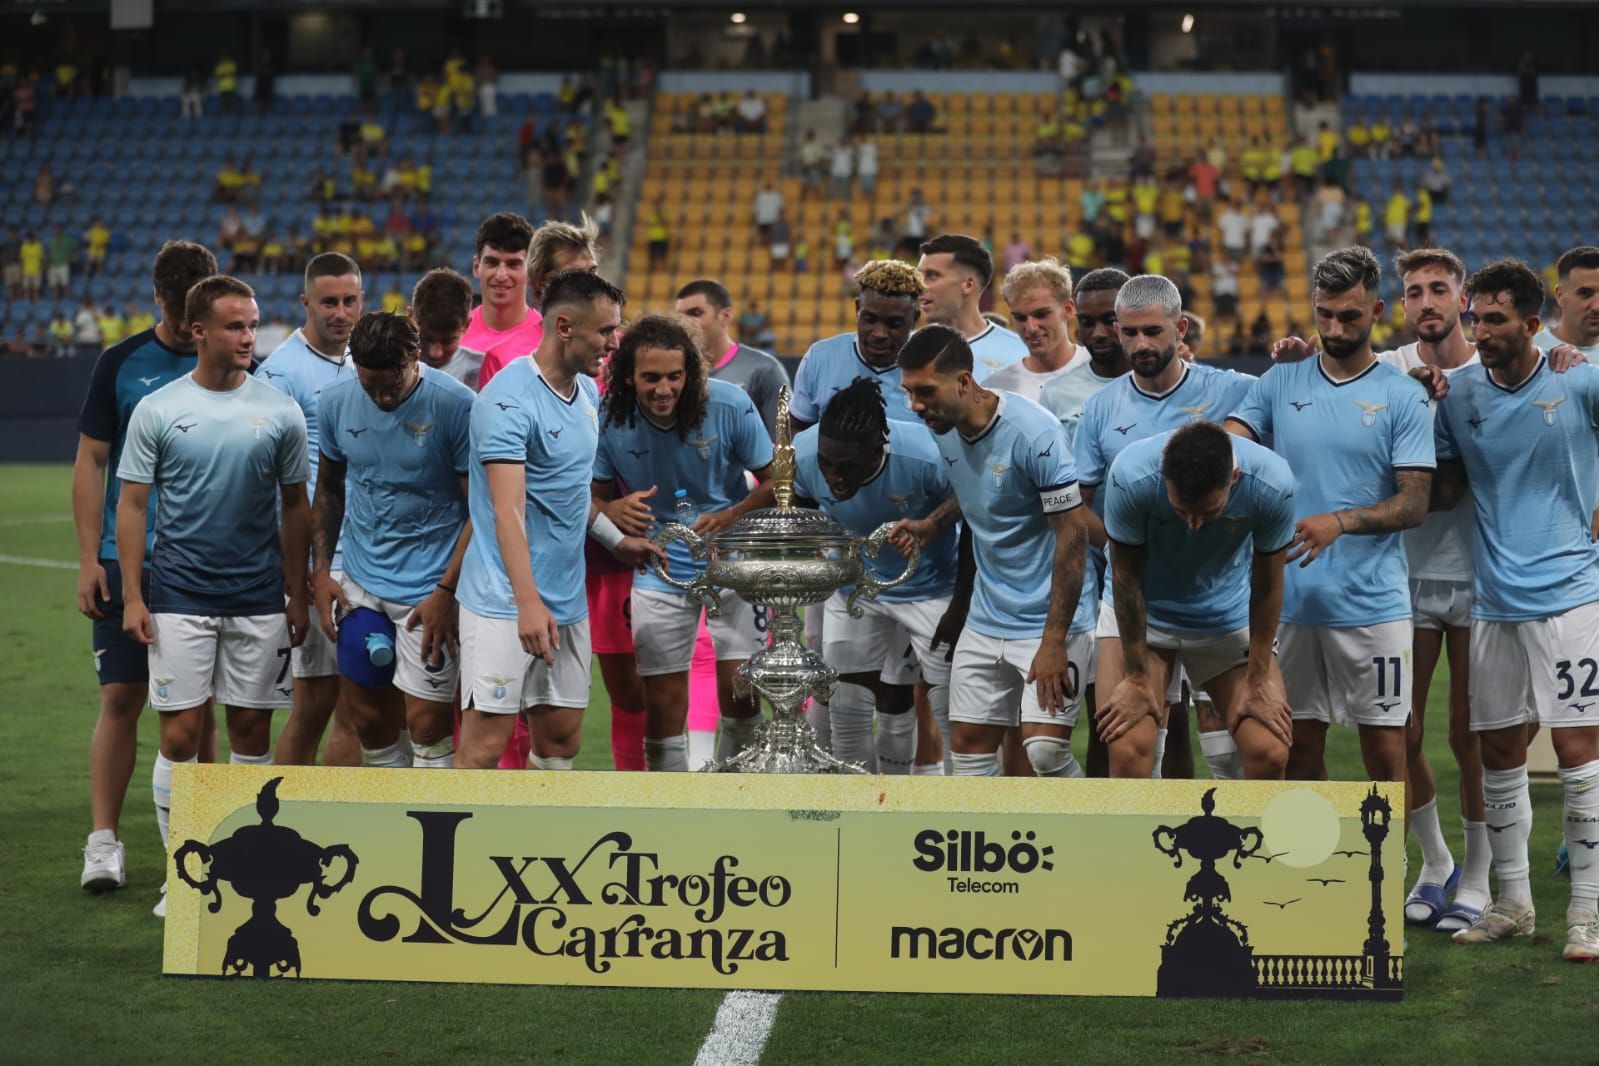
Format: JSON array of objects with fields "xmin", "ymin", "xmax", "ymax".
[{"xmin": 256, "ymin": 253, "xmax": 365, "ymax": 766}]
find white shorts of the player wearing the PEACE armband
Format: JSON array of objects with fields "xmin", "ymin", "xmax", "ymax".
[{"xmin": 950, "ymin": 630, "xmax": 1094, "ymax": 729}]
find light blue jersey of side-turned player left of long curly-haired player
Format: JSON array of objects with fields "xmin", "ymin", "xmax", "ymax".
[{"xmin": 456, "ymin": 358, "xmax": 600, "ymax": 625}]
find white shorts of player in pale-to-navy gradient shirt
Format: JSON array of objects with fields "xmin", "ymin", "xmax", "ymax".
[{"xmin": 150, "ymin": 614, "xmax": 294, "ymax": 711}]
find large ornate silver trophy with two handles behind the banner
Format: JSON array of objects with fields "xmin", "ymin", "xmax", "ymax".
[{"xmin": 651, "ymin": 387, "xmax": 921, "ymax": 774}]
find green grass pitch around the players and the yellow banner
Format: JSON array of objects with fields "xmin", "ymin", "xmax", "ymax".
[{"xmin": 0, "ymin": 467, "xmax": 1599, "ymax": 1066}]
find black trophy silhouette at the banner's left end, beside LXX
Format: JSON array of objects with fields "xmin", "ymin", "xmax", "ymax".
[{"xmin": 173, "ymin": 777, "xmax": 357, "ymax": 978}]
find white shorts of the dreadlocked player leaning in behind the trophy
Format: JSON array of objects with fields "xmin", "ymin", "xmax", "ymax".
[{"xmin": 822, "ymin": 593, "xmax": 950, "ymax": 686}]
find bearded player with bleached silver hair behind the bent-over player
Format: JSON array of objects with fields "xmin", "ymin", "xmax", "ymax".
[{"xmin": 1071, "ymin": 275, "xmax": 1254, "ymax": 777}]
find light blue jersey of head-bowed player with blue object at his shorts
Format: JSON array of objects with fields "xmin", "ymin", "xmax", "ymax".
[{"xmin": 320, "ymin": 366, "xmax": 473, "ymax": 606}]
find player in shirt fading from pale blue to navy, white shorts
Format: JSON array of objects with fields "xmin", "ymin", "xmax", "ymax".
[{"xmin": 117, "ymin": 275, "xmax": 310, "ymax": 917}]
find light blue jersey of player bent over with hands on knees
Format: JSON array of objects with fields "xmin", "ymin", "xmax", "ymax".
[{"xmin": 1105, "ymin": 433, "xmax": 1294, "ymax": 633}]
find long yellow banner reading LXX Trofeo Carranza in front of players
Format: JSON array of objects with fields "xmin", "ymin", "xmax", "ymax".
[{"xmin": 165, "ymin": 764, "xmax": 1404, "ymax": 999}]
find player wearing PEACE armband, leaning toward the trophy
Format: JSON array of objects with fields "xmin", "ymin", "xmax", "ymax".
[{"xmin": 899, "ymin": 324, "xmax": 1091, "ymax": 777}]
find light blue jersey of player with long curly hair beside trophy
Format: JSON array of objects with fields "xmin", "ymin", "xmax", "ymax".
[{"xmin": 593, "ymin": 379, "xmax": 772, "ymax": 593}]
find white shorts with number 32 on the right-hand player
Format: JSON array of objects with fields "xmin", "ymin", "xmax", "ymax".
[{"xmin": 1464, "ymin": 603, "xmax": 1599, "ymax": 732}]
